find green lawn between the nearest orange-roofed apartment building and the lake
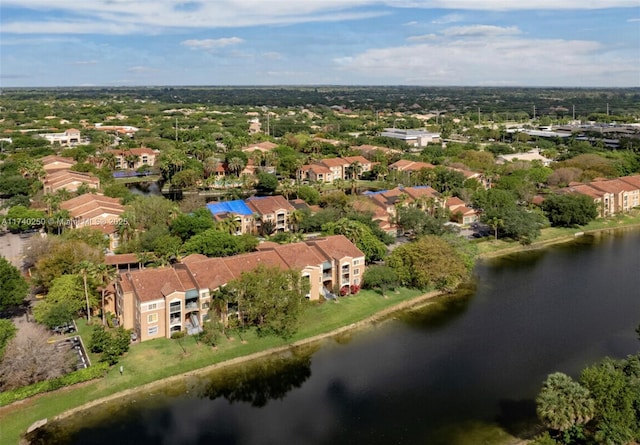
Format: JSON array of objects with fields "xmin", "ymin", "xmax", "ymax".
[{"xmin": 0, "ymin": 289, "xmax": 422, "ymax": 444}]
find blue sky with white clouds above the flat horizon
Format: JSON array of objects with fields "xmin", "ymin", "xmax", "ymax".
[{"xmin": 0, "ymin": 0, "xmax": 640, "ymax": 88}]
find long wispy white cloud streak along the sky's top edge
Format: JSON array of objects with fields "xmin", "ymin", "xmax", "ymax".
[{"xmin": 2, "ymin": 0, "xmax": 637, "ymax": 34}]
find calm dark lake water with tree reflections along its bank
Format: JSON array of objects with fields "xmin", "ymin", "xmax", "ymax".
[{"xmin": 28, "ymin": 231, "xmax": 640, "ymax": 445}]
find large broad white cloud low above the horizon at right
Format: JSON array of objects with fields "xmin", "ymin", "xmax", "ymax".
[{"xmin": 335, "ymin": 35, "xmax": 640, "ymax": 86}]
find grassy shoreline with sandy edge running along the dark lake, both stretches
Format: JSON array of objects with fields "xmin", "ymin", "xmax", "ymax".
[{"xmin": 5, "ymin": 211, "xmax": 640, "ymax": 444}]
